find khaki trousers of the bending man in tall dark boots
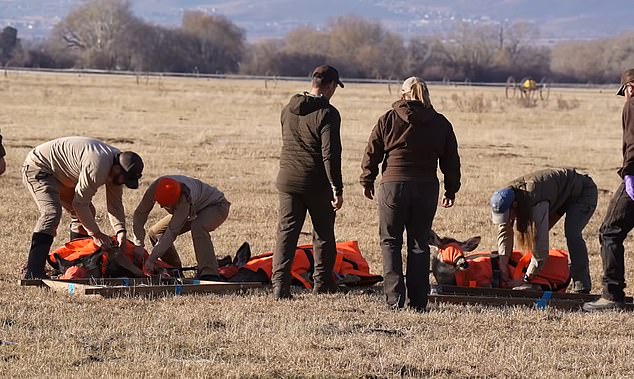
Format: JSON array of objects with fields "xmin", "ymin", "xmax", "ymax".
[{"xmin": 22, "ymin": 165, "xmax": 96, "ymax": 236}]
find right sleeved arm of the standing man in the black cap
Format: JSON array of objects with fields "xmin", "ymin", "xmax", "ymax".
[{"xmin": 320, "ymin": 109, "xmax": 343, "ymax": 196}]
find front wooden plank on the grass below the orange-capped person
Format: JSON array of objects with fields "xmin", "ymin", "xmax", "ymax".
[{"xmin": 85, "ymin": 281, "xmax": 265, "ymax": 297}]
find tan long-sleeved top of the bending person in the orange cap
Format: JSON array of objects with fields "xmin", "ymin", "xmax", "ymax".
[{"xmin": 132, "ymin": 175, "xmax": 226, "ymax": 252}]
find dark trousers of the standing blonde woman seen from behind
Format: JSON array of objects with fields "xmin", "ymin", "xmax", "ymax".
[{"xmin": 378, "ymin": 182, "xmax": 438, "ymax": 308}]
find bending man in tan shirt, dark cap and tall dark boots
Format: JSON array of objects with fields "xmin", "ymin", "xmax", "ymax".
[{"xmin": 22, "ymin": 137, "xmax": 143, "ymax": 279}]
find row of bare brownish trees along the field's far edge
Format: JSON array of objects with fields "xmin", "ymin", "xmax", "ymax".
[{"xmin": 0, "ymin": 0, "xmax": 634, "ymax": 83}]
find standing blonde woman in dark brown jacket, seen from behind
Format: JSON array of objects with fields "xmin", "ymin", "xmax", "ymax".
[{"xmin": 360, "ymin": 77, "xmax": 460, "ymax": 312}]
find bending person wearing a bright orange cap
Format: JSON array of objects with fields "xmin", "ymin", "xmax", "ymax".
[{"xmin": 132, "ymin": 175, "xmax": 231, "ymax": 280}]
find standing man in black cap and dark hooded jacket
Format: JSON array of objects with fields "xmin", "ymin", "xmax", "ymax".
[{"xmin": 271, "ymin": 65, "xmax": 343, "ymax": 299}]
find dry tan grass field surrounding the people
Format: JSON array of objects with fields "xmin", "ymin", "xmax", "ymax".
[{"xmin": 0, "ymin": 72, "xmax": 634, "ymax": 378}]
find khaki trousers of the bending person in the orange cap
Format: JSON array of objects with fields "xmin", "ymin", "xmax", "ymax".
[{"xmin": 148, "ymin": 200, "xmax": 230, "ymax": 276}]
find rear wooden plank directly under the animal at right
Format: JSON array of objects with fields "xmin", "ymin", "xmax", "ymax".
[{"xmin": 432, "ymin": 285, "xmax": 632, "ymax": 303}]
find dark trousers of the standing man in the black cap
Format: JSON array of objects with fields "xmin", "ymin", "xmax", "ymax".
[{"xmin": 271, "ymin": 189, "xmax": 337, "ymax": 288}]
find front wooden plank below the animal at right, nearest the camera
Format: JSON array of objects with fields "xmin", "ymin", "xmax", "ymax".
[{"xmin": 429, "ymin": 295, "xmax": 634, "ymax": 311}]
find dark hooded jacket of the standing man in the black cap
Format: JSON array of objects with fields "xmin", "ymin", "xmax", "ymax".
[{"xmin": 277, "ymin": 93, "xmax": 343, "ymax": 194}]
